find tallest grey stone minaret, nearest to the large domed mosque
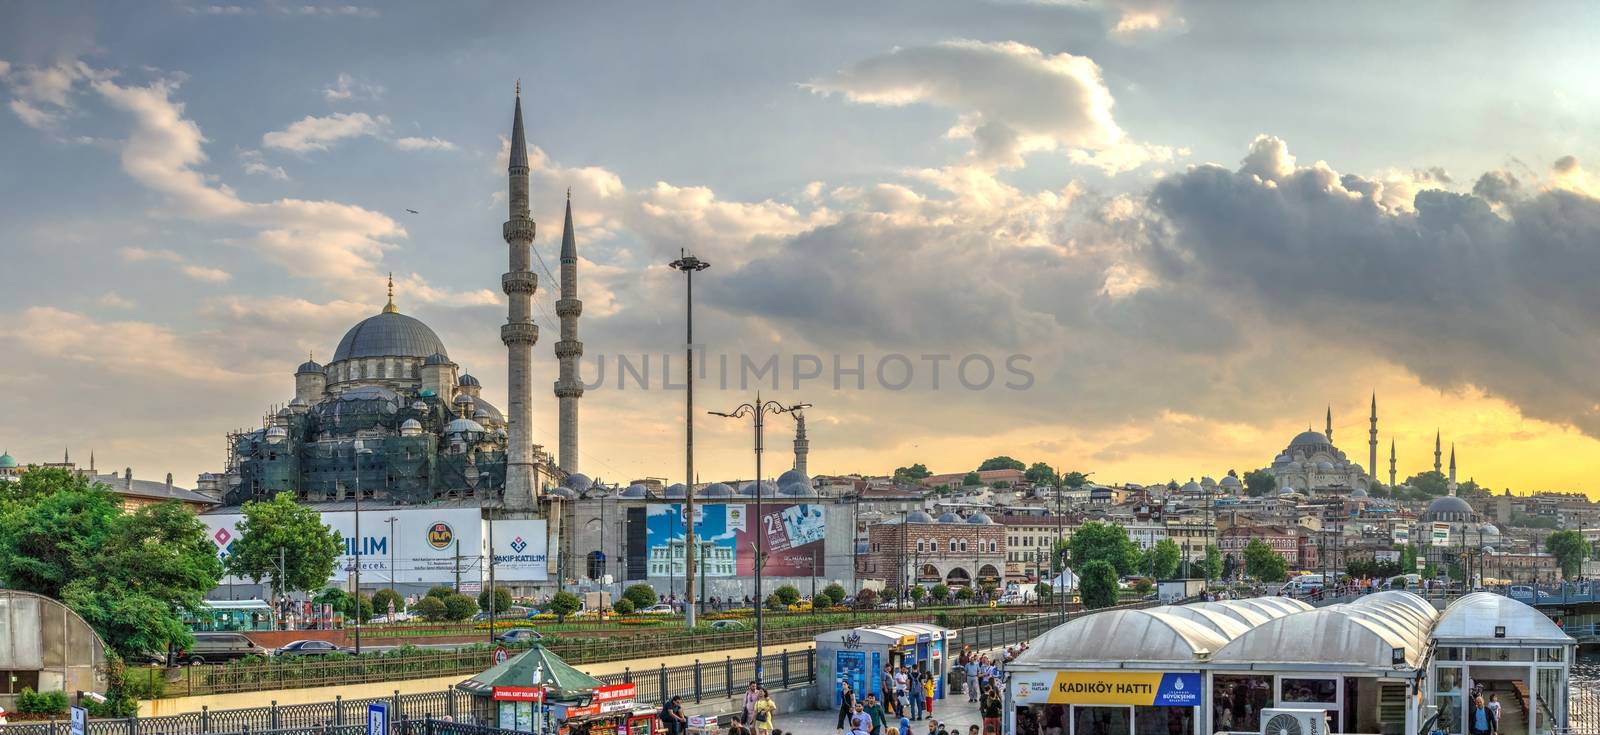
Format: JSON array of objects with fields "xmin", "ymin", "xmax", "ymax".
[{"xmin": 501, "ymin": 82, "xmax": 539, "ymax": 511}]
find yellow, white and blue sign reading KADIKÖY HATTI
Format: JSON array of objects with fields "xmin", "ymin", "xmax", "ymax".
[{"xmin": 1011, "ymin": 671, "xmax": 1200, "ymax": 706}]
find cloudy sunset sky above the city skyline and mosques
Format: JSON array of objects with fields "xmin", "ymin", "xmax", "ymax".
[{"xmin": 0, "ymin": 0, "xmax": 1600, "ymax": 492}]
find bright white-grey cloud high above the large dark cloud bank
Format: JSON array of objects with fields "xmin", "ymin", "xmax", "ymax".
[{"xmin": 808, "ymin": 40, "xmax": 1174, "ymax": 173}]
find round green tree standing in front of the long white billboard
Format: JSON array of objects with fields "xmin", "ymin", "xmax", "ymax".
[{"xmin": 227, "ymin": 493, "xmax": 344, "ymax": 597}]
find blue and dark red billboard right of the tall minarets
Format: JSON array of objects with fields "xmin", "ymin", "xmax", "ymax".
[{"xmin": 643, "ymin": 503, "xmax": 827, "ymax": 578}]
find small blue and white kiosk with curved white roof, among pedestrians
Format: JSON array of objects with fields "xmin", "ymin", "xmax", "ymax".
[{"xmin": 814, "ymin": 623, "xmax": 955, "ymax": 709}]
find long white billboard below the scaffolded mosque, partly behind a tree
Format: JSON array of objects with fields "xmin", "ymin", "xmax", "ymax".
[{"xmin": 200, "ymin": 508, "xmax": 547, "ymax": 584}]
